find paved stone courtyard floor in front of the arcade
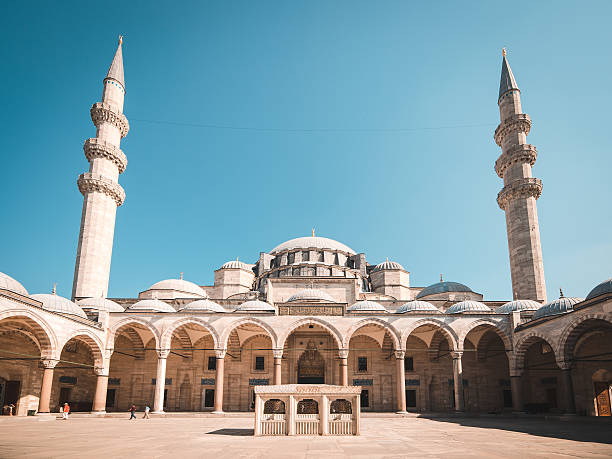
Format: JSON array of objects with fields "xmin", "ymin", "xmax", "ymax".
[{"xmin": 0, "ymin": 413, "xmax": 612, "ymax": 459}]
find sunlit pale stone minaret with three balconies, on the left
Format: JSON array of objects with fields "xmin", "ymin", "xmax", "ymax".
[{"xmin": 72, "ymin": 37, "xmax": 130, "ymax": 299}]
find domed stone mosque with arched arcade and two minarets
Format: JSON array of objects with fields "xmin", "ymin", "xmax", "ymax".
[{"xmin": 0, "ymin": 40, "xmax": 612, "ymax": 416}]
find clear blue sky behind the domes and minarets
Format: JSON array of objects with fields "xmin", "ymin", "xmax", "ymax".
[{"xmin": 0, "ymin": 1, "xmax": 612, "ymax": 300}]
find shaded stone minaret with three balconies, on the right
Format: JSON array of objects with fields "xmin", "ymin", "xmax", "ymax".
[{"xmin": 495, "ymin": 49, "xmax": 546, "ymax": 301}]
